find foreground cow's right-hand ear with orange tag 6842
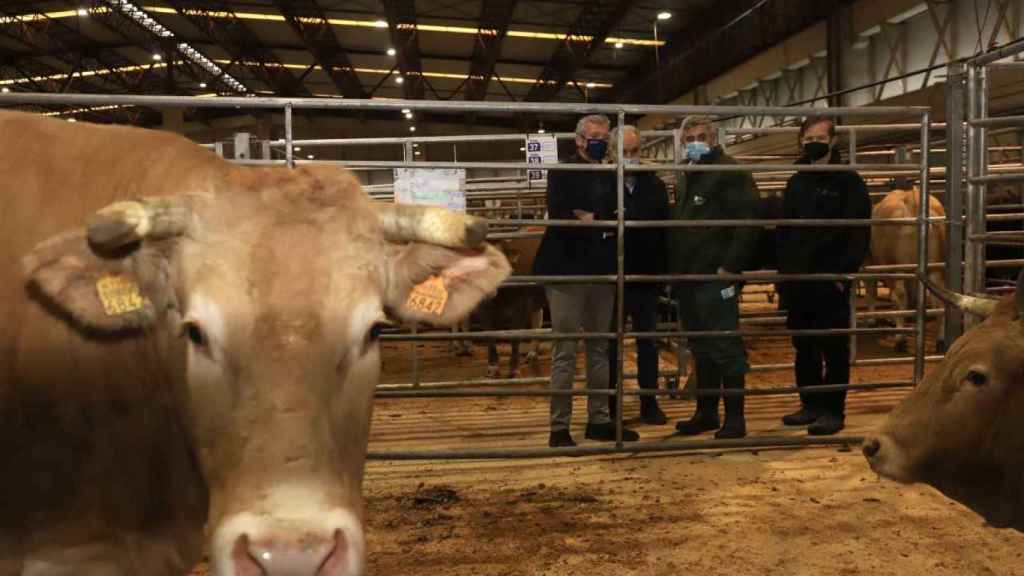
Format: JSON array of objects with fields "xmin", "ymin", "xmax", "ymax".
[{"xmin": 385, "ymin": 239, "xmax": 511, "ymax": 326}]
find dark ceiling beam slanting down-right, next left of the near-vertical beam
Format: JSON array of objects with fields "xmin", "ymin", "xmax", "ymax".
[{"xmin": 274, "ymin": 0, "xmax": 367, "ymax": 98}]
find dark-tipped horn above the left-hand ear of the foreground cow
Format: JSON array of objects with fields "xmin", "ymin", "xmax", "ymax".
[{"xmin": 86, "ymin": 197, "xmax": 191, "ymax": 251}]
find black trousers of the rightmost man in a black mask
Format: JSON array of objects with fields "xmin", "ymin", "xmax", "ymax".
[{"xmin": 786, "ymin": 282, "xmax": 851, "ymax": 416}]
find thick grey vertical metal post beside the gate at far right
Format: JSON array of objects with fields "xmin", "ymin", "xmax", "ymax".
[{"xmin": 945, "ymin": 63, "xmax": 967, "ymax": 345}]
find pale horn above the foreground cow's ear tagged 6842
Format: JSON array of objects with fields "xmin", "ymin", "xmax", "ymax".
[{"xmin": 377, "ymin": 204, "xmax": 487, "ymax": 248}]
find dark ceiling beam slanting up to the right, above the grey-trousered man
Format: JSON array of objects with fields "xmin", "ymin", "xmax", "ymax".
[{"xmin": 526, "ymin": 0, "xmax": 634, "ymax": 101}]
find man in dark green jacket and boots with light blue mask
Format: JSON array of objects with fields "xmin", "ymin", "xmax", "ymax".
[{"xmin": 668, "ymin": 117, "xmax": 760, "ymax": 439}]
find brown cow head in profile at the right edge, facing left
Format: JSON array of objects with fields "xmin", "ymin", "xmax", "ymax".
[{"xmin": 863, "ymin": 272, "xmax": 1024, "ymax": 526}]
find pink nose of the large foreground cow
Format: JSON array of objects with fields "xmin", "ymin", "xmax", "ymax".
[{"xmin": 231, "ymin": 530, "xmax": 348, "ymax": 576}]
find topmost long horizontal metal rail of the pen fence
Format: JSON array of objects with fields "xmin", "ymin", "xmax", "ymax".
[{"xmin": 0, "ymin": 92, "xmax": 929, "ymax": 118}]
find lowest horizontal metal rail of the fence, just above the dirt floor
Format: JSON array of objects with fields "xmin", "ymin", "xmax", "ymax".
[{"xmin": 367, "ymin": 436, "xmax": 864, "ymax": 460}]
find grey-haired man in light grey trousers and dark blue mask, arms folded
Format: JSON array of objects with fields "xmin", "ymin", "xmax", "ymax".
[{"xmin": 534, "ymin": 115, "xmax": 639, "ymax": 448}]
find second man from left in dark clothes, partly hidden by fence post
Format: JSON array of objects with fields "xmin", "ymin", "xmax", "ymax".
[{"xmin": 608, "ymin": 125, "xmax": 669, "ymax": 424}]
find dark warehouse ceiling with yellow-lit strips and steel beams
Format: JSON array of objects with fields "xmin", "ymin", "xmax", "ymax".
[{"xmin": 0, "ymin": 0, "xmax": 840, "ymax": 124}]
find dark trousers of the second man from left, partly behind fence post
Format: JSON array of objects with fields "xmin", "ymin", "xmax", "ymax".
[{"xmin": 608, "ymin": 284, "xmax": 658, "ymax": 398}]
